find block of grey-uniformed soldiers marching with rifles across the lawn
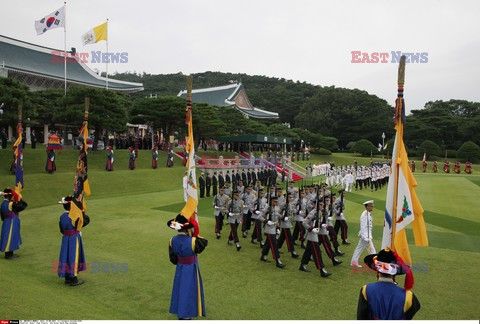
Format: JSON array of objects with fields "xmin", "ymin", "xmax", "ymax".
[{"xmin": 213, "ymin": 181, "xmax": 350, "ymax": 277}]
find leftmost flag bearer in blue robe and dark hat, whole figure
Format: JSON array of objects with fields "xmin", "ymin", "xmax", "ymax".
[{"xmin": 0, "ymin": 188, "xmax": 27, "ymax": 259}]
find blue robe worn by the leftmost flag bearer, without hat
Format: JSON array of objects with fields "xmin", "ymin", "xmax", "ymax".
[{"xmin": 0, "ymin": 199, "xmax": 22, "ymax": 252}]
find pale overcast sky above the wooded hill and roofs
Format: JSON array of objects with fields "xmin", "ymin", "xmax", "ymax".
[{"xmin": 0, "ymin": 0, "xmax": 480, "ymax": 111}]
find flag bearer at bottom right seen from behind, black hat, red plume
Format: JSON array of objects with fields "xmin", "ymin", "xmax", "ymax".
[{"xmin": 357, "ymin": 248, "xmax": 420, "ymax": 321}]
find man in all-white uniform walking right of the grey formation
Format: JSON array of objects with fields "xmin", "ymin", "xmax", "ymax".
[{"xmin": 350, "ymin": 200, "xmax": 377, "ymax": 268}]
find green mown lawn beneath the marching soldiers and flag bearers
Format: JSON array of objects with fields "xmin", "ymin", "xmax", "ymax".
[{"xmin": 0, "ymin": 149, "xmax": 480, "ymax": 320}]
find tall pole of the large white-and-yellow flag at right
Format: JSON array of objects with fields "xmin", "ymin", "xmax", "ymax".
[{"xmin": 390, "ymin": 55, "xmax": 405, "ymax": 251}]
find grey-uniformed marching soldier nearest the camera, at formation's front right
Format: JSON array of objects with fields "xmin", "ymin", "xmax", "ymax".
[{"xmin": 299, "ymin": 202, "xmax": 331, "ymax": 277}]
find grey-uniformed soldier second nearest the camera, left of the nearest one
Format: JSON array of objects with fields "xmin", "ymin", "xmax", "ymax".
[{"xmin": 260, "ymin": 196, "xmax": 285, "ymax": 268}]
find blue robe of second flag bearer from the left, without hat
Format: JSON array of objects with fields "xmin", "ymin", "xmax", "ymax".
[{"xmin": 58, "ymin": 212, "xmax": 87, "ymax": 277}]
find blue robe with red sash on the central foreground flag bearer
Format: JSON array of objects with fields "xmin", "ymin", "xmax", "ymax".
[{"xmin": 169, "ymin": 234, "xmax": 208, "ymax": 318}]
